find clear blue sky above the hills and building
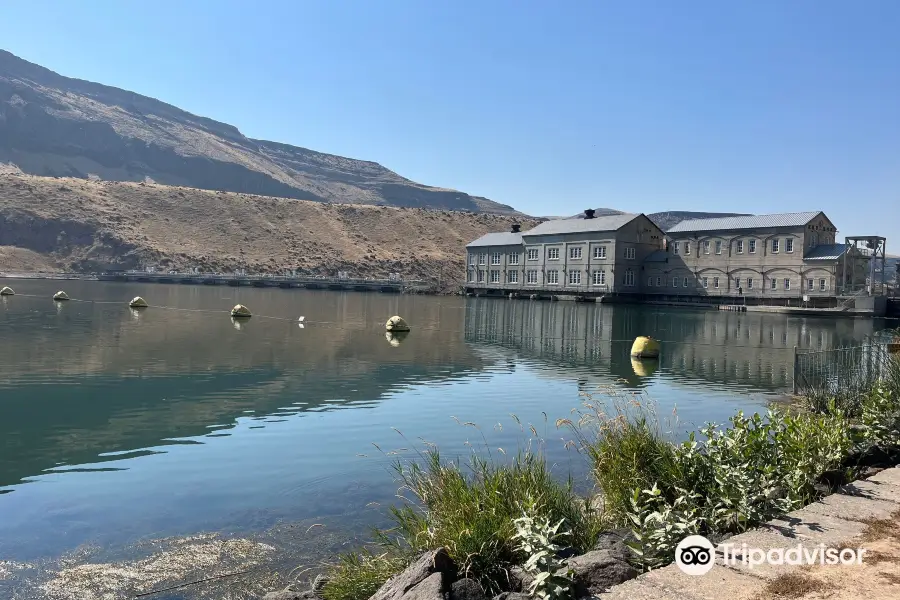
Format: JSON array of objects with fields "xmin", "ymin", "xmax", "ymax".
[{"xmin": 0, "ymin": 0, "xmax": 900, "ymax": 244}]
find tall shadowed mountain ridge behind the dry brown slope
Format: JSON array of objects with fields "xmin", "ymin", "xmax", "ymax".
[{"xmin": 0, "ymin": 50, "xmax": 517, "ymax": 214}]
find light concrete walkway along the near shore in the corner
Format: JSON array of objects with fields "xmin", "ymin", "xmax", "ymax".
[{"xmin": 599, "ymin": 467, "xmax": 900, "ymax": 600}]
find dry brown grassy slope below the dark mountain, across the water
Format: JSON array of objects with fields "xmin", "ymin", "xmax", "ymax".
[{"xmin": 0, "ymin": 173, "xmax": 535, "ymax": 282}]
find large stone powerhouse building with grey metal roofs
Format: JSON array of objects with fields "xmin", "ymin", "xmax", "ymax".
[{"xmin": 466, "ymin": 210, "xmax": 868, "ymax": 306}]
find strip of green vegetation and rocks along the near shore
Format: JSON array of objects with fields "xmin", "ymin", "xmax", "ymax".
[{"xmin": 267, "ymin": 332, "xmax": 900, "ymax": 600}]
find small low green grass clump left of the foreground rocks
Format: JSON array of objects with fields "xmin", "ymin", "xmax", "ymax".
[{"xmin": 322, "ymin": 552, "xmax": 408, "ymax": 600}]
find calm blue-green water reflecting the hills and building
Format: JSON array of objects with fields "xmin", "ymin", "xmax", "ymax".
[{"xmin": 0, "ymin": 281, "xmax": 878, "ymax": 584}]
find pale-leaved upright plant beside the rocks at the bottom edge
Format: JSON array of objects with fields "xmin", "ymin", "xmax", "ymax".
[{"xmin": 513, "ymin": 500, "xmax": 574, "ymax": 600}]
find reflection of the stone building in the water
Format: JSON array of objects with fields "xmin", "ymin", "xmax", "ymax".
[{"xmin": 465, "ymin": 298, "xmax": 879, "ymax": 393}]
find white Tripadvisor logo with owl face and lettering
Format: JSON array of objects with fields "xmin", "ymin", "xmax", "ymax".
[{"xmin": 675, "ymin": 535, "xmax": 866, "ymax": 575}]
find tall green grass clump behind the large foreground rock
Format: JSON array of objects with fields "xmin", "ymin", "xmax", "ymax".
[{"xmin": 379, "ymin": 449, "xmax": 604, "ymax": 593}]
